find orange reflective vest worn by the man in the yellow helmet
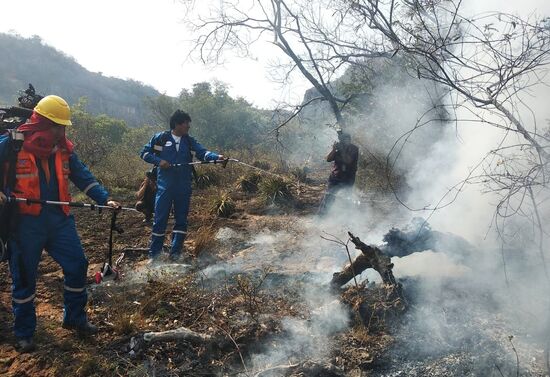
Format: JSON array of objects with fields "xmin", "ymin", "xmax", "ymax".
[{"xmin": 13, "ymin": 149, "xmax": 71, "ymax": 216}]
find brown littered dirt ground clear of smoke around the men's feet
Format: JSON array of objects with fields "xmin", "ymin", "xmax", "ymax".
[{"xmin": 0, "ymin": 175, "xmax": 398, "ymax": 376}]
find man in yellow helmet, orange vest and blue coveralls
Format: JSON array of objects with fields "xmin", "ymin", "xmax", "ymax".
[{"xmin": 0, "ymin": 95, "xmax": 119, "ymax": 352}]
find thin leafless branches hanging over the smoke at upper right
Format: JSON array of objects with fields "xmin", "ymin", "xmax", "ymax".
[{"xmin": 341, "ymin": 0, "xmax": 550, "ymax": 278}]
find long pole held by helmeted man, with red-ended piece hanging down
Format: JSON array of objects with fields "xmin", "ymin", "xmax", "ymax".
[{"xmin": 7, "ymin": 196, "xmax": 138, "ymax": 284}]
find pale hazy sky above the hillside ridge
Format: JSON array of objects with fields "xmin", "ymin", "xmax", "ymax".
[{"xmin": 0, "ymin": 0, "xmax": 550, "ymax": 107}]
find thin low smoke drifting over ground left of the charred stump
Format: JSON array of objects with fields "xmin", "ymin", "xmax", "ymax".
[{"xmin": 202, "ymin": 223, "xmax": 355, "ymax": 371}]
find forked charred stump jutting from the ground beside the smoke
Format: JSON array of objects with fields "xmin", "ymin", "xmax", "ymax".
[{"xmin": 330, "ymin": 232, "xmax": 397, "ymax": 288}]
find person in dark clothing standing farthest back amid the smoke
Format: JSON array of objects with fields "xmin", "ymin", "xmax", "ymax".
[{"xmin": 318, "ymin": 131, "xmax": 359, "ymax": 215}]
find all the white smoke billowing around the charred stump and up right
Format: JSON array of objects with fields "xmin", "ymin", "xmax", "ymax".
[{"xmin": 207, "ymin": 0, "xmax": 550, "ymax": 375}]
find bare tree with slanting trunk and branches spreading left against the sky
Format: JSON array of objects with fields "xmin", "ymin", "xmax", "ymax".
[{"xmin": 184, "ymin": 0, "xmax": 402, "ymax": 127}]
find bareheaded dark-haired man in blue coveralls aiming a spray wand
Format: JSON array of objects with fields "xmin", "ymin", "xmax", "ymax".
[{"xmin": 141, "ymin": 110, "xmax": 223, "ymax": 262}]
